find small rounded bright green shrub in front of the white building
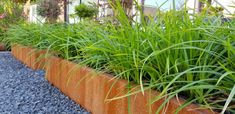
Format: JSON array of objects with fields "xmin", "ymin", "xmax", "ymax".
[{"xmin": 75, "ymin": 4, "xmax": 98, "ymax": 18}]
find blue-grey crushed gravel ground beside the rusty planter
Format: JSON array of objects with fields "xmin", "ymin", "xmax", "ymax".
[{"xmin": 0, "ymin": 52, "xmax": 89, "ymax": 114}]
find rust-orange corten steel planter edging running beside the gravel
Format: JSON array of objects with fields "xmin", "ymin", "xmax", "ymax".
[{"xmin": 12, "ymin": 45, "xmax": 215, "ymax": 114}]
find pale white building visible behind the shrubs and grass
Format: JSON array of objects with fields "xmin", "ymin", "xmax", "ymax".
[{"xmin": 25, "ymin": 0, "xmax": 235, "ymax": 23}]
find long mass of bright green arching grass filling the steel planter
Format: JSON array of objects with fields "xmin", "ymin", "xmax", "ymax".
[{"xmin": 2, "ymin": 0, "xmax": 235, "ymax": 113}]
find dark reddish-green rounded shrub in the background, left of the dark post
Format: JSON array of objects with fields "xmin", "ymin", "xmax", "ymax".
[{"xmin": 37, "ymin": 0, "xmax": 62, "ymax": 23}]
